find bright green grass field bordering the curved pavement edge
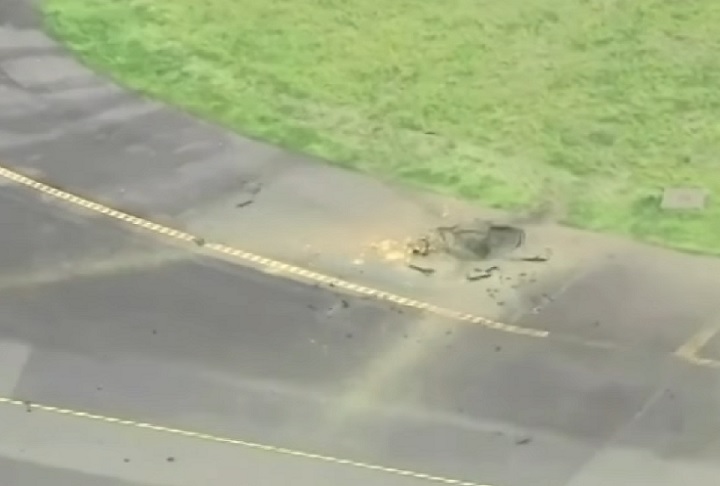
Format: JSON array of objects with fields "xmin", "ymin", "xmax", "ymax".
[{"xmin": 44, "ymin": 0, "xmax": 720, "ymax": 254}]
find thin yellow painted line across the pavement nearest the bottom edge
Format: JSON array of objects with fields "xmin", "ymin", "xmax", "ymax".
[{"xmin": 0, "ymin": 397, "xmax": 490, "ymax": 486}]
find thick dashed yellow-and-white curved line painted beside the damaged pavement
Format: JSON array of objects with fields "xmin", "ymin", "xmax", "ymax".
[{"xmin": 0, "ymin": 166, "xmax": 550, "ymax": 338}]
